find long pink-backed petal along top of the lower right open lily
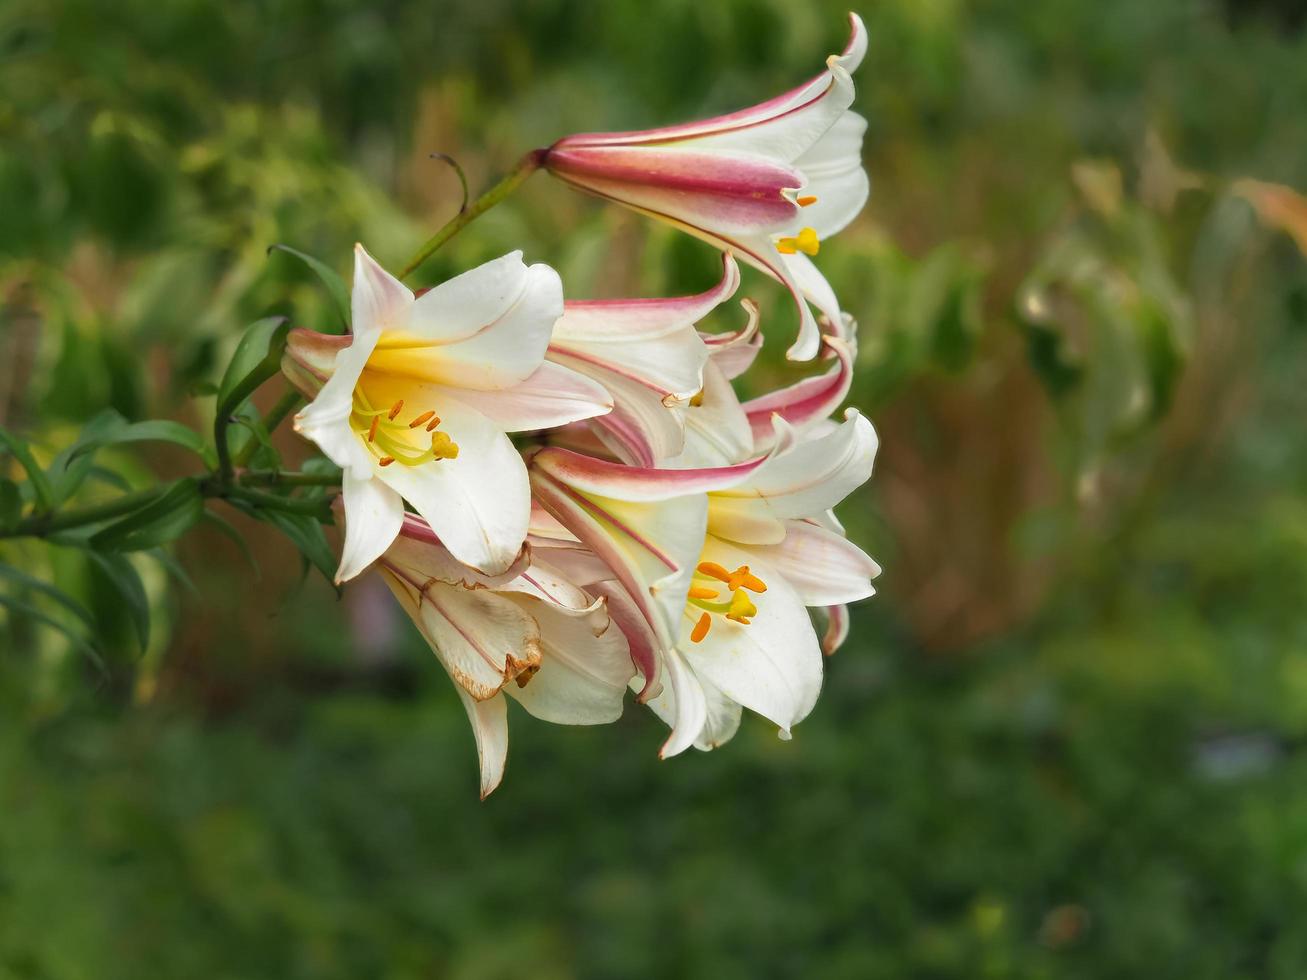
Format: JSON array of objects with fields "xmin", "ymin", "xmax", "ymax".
[{"xmin": 532, "ymin": 447, "xmax": 765, "ymax": 506}]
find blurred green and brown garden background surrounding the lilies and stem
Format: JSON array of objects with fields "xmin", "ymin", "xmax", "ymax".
[{"xmin": 0, "ymin": 0, "xmax": 1307, "ymax": 980}]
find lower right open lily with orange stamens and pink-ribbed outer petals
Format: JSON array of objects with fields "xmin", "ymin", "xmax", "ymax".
[{"xmin": 529, "ymin": 409, "xmax": 880, "ymax": 757}]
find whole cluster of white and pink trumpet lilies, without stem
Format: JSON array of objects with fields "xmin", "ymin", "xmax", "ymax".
[{"xmin": 284, "ymin": 16, "xmax": 880, "ymax": 794}]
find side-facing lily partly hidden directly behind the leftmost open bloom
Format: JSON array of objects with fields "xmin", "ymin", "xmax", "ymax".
[{"xmin": 545, "ymin": 255, "xmax": 740, "ymax": 466}]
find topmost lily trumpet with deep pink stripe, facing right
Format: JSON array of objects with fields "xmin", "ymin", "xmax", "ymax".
[{"xmin": 542, "ymin": 14, "xmax": 869, "ymax": 361}]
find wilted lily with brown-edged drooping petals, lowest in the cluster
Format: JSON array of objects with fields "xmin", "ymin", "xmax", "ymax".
[{"xmin": 376, "ymin": 515, "xmax": 635, "ymax": 800}]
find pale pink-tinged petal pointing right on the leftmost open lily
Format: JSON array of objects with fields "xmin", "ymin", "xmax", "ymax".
[{"xmin": 451, "ymin": 361, "xmax": 613, "ymax": 433}]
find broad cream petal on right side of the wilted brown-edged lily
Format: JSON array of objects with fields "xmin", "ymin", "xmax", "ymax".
[{"xmin": 505, "ymin": 595, "xmax": 635, "ymax": 725}]
